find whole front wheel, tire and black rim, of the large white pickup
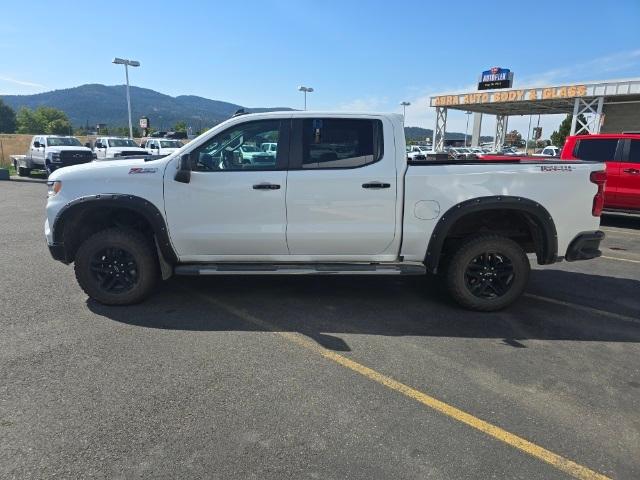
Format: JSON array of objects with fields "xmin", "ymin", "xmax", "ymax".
[{"xmin": 74, "ymin": 228, "xmax": 159, "ymax": 305}]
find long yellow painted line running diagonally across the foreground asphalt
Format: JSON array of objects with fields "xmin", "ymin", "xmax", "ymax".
[{"xmin": 200, "ymin": 294, "xmax": 609, "ymax": 480}]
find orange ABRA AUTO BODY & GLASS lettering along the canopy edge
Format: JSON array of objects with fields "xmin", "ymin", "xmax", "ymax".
[{"xmin": 431, "ymin": 85, "xmax": 587, "ymax": 107}]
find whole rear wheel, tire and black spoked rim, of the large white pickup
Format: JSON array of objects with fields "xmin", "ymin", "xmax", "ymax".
[{"xmin": 446, "ymin": 235, "xmax": 531, "ymax": 312}]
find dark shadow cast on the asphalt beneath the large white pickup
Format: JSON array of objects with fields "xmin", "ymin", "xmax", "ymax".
[{"xmin": 87, "ymin": 270, "xmax": 640, "ymax": 351}]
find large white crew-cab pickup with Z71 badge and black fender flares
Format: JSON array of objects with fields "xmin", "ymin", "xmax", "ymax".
[{"xmin": 45, "ymin": 112, "xmax": 606, "ymax": 311}]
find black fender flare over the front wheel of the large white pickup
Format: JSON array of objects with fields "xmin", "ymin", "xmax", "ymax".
[{"xmin": 52, "ymin": 194, "xmax": 178, "ymax": 264}]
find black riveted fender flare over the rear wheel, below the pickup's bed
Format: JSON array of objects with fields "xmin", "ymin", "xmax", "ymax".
[{"xmin": 424, "ymin": 195, "xmax": 558, "ymax": 273}]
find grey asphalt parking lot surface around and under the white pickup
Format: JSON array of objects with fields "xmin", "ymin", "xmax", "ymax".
[{"xmin": 0, "ymin": 181, "xmax": 640, "ymax": 479}]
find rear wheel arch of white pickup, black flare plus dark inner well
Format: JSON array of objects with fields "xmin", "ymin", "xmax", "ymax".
[{"xmin": 424, "ymin": 196, "xmax": 558, "ymax": 273}]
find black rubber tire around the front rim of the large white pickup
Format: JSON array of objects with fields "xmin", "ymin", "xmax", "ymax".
[{"xmin": 74, "ymin": 228, "xmax": 160, "ymax": 305}]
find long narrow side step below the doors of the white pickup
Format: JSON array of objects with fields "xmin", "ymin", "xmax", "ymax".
[{"xmin": 174, "ymin": 263, "xmax": 427, "ymax": 275}]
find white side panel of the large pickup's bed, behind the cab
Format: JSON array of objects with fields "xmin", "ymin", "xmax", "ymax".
[{"xmin": 402, "ymin": 161, "xmax": 605, "ymax": 261}]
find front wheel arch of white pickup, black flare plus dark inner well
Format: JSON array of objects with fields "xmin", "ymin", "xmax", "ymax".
[{"xmin": 52, "ymin": 194, "xmax": 178, "ymax": 264}]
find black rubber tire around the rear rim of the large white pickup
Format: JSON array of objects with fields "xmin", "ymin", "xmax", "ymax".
[{"xmin": 445, "ymin": 235, "xmax": 531, "ymax": 312}]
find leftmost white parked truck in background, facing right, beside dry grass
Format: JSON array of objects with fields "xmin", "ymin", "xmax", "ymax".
[{"xmin": 14, "ymin": 135, "xmax": 94, "ymax": 177}]
